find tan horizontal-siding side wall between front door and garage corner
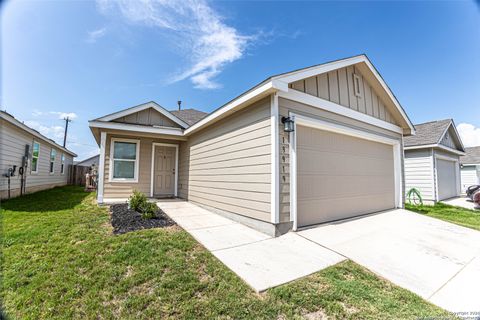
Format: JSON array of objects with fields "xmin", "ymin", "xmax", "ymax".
[{"xmin": 179, "ymin": 98, "xmax": 272, "ymax": 221}]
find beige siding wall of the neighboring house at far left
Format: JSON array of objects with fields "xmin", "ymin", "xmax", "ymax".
[{"xmin": 0, "ymin": 119, "xmax": 73, "ymax": 196}]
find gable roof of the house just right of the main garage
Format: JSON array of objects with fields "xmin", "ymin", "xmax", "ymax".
[{"xmin": 403, "ymin": 119, "xmax": 465, "ymax": 154}]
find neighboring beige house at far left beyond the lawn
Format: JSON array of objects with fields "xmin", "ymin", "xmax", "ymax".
[{"xmin": 0, "ymin": 111, "xmax": 76, "ymax": 199}]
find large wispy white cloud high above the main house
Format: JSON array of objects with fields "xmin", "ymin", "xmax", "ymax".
[{"xmin": 97, "ymin": 0, "xmax": 257, "ymax": 89}]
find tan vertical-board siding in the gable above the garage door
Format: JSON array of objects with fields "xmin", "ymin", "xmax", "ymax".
[{"xmin": 290, "ymin": 65, "xmax": 398, "ymax": 124}]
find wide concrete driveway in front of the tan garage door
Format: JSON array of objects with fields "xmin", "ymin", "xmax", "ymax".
[{"xmin": 298, "ymin": 210, "xmax": 480, "ymax": 312}]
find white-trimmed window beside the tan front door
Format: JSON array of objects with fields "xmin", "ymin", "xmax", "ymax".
[{"xmin": 110, "ymin": 139, "xmax": 140, "ymax": 182}]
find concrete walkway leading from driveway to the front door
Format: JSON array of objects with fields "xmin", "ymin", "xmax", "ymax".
[{"xmin": 157, "ymin": 200, "xmax": 345, "ymax": 292}]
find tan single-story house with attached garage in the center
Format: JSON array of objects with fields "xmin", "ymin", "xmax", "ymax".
[{"xmin": 89, "ymin": 55, "xmax": 414, "ymax": 235}]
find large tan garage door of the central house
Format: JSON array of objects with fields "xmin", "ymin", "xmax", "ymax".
[{"xmin": 297, "ymin": 126, "xmax": 395, "ymax": 227}]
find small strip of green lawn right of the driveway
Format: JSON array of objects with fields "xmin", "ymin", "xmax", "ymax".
[{"xmin": 405, "ymin": 202, "xmax": 480, "ymax": 230}]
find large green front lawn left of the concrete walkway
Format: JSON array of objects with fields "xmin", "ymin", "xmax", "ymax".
[{"xmin": 1, "ymin": 187, "xmax": 448, "ymax": 319}]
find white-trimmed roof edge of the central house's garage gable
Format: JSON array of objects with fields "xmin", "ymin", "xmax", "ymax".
[{"xmin": 185, "ymin": 54, "xmax": 415, "ymax": 135}]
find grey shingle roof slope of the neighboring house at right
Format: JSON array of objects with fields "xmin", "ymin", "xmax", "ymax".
[{"xmin": 403, "ymin": 119, "xmax": 452, "ymax": 147}]
